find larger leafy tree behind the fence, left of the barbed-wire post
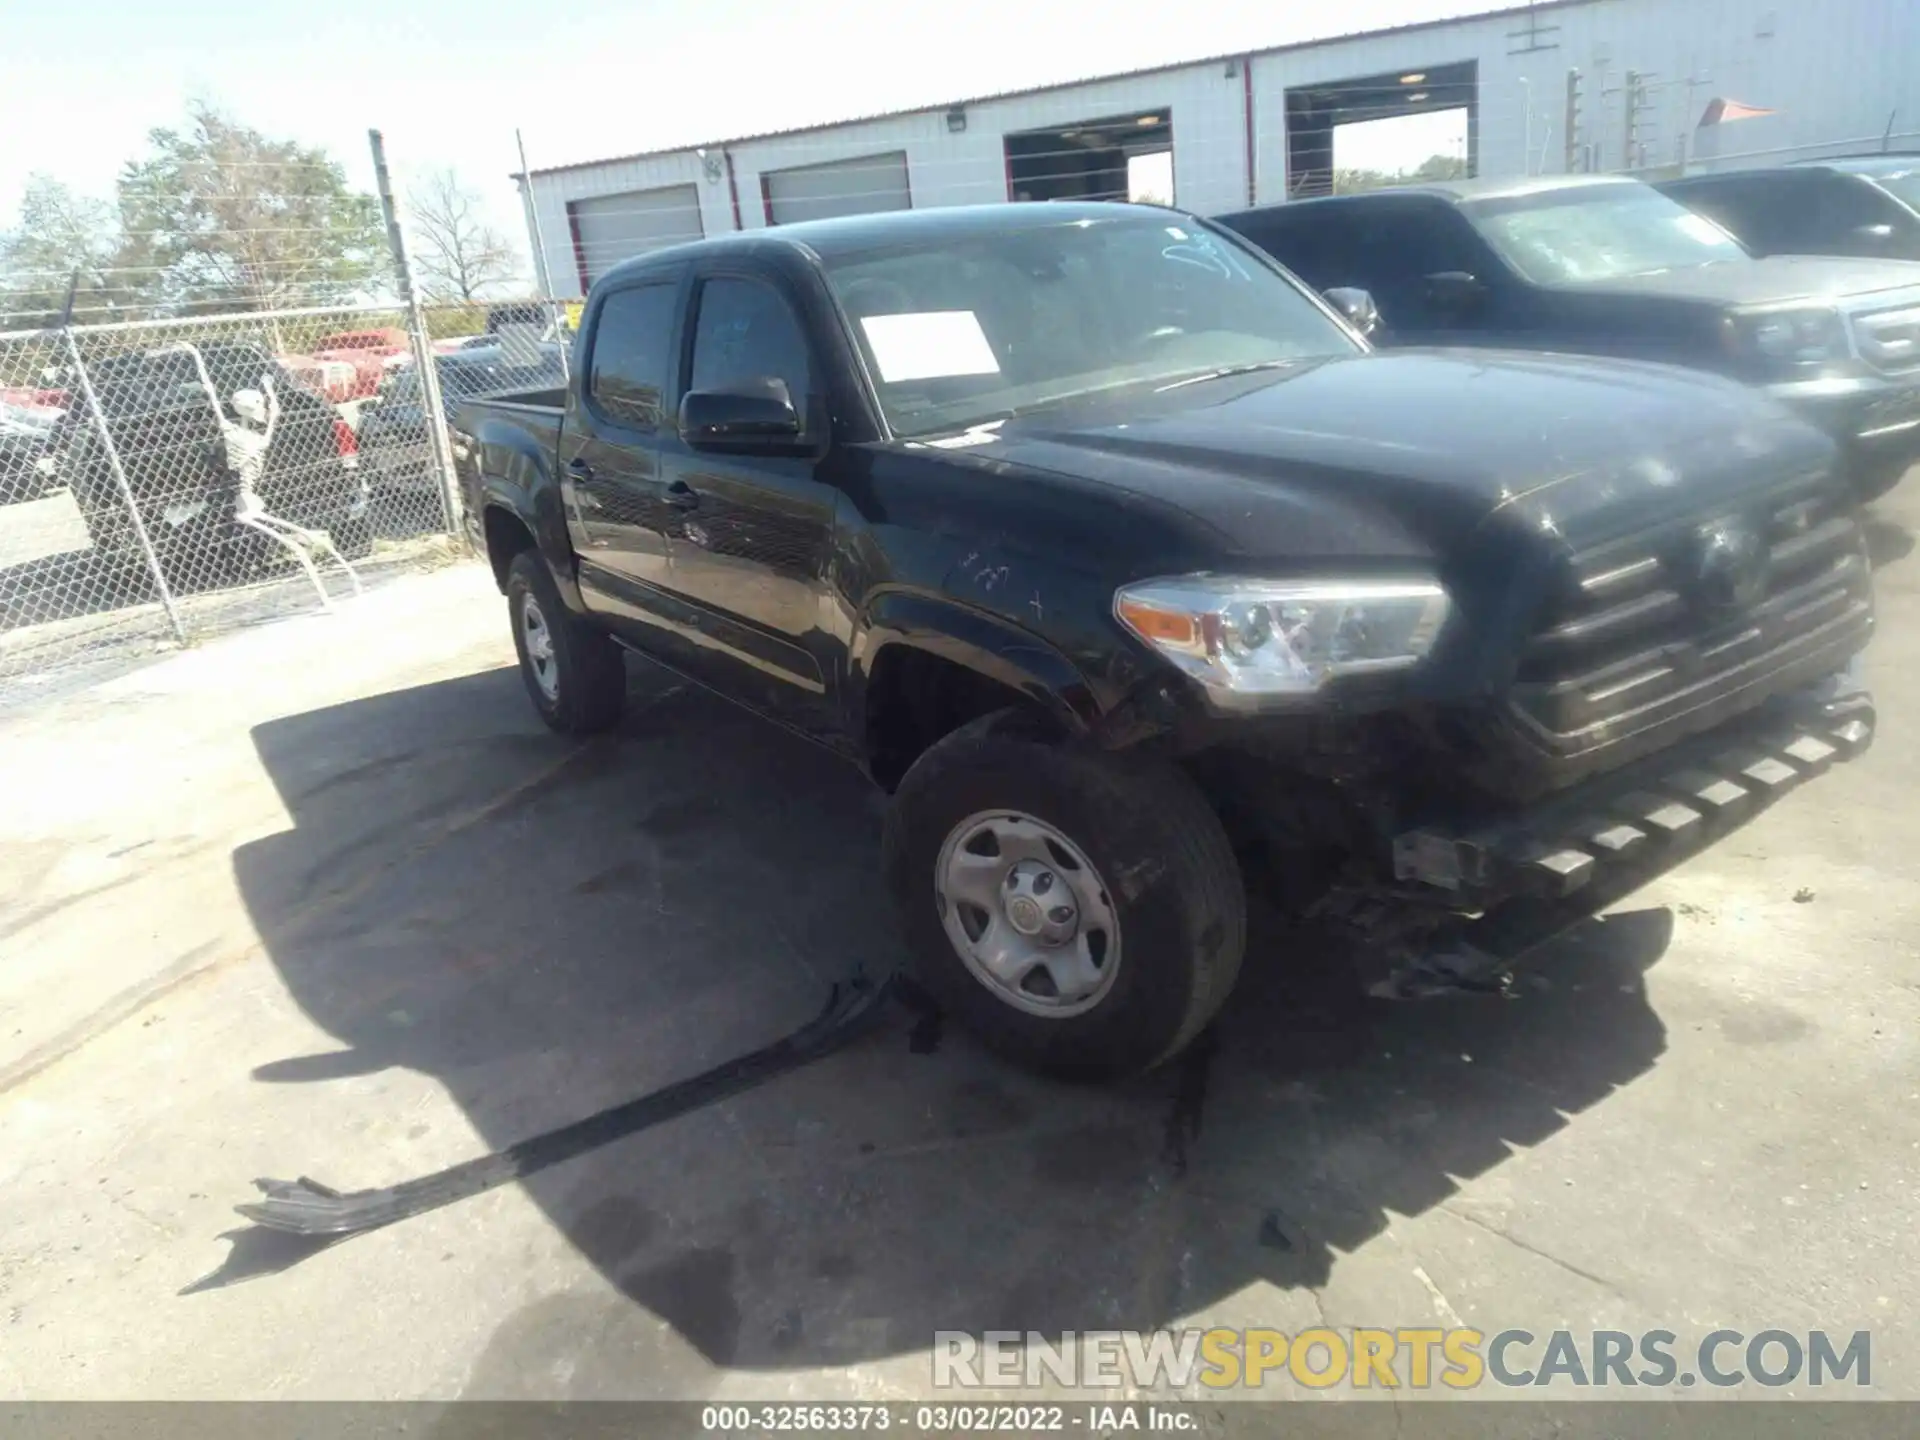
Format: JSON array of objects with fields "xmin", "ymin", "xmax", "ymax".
[{"xmin": 119, "ymin": 102, "xmax": 390, "ymax": 311}]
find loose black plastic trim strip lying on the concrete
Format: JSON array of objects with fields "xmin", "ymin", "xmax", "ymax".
[{"xmin": 234, "ymin": 975, "xmax": 897, "ymax": 1236}]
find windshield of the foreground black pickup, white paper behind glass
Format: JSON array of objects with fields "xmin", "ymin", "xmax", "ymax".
[{"xmin": 826, "ymin": 215, "xmax": 1359, "ymax": 436}]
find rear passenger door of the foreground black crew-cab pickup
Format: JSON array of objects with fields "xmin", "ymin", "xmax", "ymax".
[{"xmin": 559, "ymin": 273, "xmax": 682, "ymax": 649}]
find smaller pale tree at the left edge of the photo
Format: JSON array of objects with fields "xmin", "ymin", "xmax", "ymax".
[{"xmin": 0, "ymin": 175, "xmax": 142, "ymax": 328}]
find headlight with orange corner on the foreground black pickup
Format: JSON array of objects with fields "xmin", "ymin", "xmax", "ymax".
[{"xmin": 1114, "ymin": 576, "xmax": 1450, "ymax": 707}]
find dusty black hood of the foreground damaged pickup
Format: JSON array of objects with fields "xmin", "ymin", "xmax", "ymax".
[{"xmin": 975, "ymin": 349, "xmax": 1832, "ymax": 561}]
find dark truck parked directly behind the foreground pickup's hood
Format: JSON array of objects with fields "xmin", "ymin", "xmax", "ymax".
[{"xmin": 1219, "ymin": 175, "xmax": 1920, "ymax": 499}]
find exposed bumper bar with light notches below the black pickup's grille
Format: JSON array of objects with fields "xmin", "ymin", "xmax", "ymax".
[{"xmin": 1369, "ymin": 660, "xmax": 1874, "ymax": 996}]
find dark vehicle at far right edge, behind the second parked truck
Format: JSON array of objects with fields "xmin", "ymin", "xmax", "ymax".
[{"xmin": 1659, "ymin": 156, "xmax": 1920, "ymax": 259}]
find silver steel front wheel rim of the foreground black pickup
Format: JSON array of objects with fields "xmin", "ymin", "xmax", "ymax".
[{"xmin": 933, "ymin": 810, "xmax": 1121, "ymax": 1020}]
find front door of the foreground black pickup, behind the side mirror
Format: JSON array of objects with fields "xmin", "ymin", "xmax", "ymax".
[{"xmin": 660, "ymin": 263, "xmax": 837, "ymax": 739}]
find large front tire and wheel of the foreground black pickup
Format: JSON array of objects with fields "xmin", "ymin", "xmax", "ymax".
[{"xmin": 883, "ymin": 710, "xmax": 1246, "ymax": 1081}]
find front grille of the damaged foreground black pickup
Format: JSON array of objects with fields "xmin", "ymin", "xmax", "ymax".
[{"xmin": 1511, "ymin": 480, "xmax": 1872, "ymax": 756}]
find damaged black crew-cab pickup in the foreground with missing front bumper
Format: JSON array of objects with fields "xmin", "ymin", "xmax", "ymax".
[{"xmin": 453, "ymin": 204, "xmax": 1874, "ymax": 1075}]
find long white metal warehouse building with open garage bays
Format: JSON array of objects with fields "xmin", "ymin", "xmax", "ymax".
[{"xmin": 520, "ymin": 0, "xmax": 1920, "ymax": 296}]
